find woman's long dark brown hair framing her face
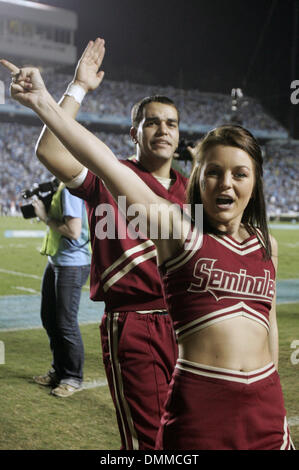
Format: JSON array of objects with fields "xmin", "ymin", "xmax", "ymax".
[{"xmin": 187, "ymin": 125, "xmax": 272, "ymax": 259}]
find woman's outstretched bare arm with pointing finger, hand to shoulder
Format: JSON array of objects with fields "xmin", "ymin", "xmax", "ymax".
[{"xmin": 0, "ymin": 51, "xmax": 193, "ymax": 261}]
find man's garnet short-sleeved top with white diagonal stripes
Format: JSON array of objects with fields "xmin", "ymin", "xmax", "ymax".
[{"xmin": 69, "ymin": 160, "xmax": 187, "ymax": 312}]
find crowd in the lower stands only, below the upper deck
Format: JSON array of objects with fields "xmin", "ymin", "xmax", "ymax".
[{"xmin": 0, "ymin": 123, "xmax": 299, "ymax": 215}]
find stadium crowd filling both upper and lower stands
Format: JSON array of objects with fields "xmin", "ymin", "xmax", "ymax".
[{"xmin": 0, "ymin": 69, "xmax": 299, "ymax": 215}]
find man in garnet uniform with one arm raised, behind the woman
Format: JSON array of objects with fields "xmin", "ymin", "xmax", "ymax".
[{"xmin": 11, "ymin": 38, "xmax": 191, "ymax": 450}]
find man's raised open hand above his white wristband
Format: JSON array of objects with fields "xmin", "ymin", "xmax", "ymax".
[{"xmin": 73, "ymin": 38, "xmax": 105, "ymax": 92}]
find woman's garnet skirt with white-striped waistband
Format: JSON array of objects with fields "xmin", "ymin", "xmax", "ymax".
[{"xmin": 156, "ymin": 359, "xmax": 294, "ymax": 450}]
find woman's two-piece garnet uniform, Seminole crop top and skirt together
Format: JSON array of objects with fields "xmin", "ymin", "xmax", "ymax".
[{"xmin": 156, "ymin": 230, "xmax": 294, "ymax": 450}]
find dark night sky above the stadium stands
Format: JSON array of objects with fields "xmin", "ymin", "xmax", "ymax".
[{"xmin": 32, "ymin": 0, "xmax": 299, "ymax": 136}]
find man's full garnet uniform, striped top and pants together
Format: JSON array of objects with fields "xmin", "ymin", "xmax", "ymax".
[{"xmin": 70, "ymin": 160, "xmax": 187, "ymax": 450}]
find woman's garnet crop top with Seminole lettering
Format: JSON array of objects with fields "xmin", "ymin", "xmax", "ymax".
[{"xmin": 159, "ymin": 232, "xmax": 275, "ymax": 340}]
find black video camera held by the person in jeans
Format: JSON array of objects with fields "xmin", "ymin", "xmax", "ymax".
[{"xmin": 20, "ymin": 177, "xmax": 59, "ymax": 219}]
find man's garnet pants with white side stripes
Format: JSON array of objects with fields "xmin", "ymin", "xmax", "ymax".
[{"xmin": 100, "ymin": 310, "xmax": 178, "ymax": 450}]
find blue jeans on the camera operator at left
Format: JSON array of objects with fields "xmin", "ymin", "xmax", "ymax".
[{"xmin": 41, "ymin": 263, "xmax": 90, "ymax": 387}]
